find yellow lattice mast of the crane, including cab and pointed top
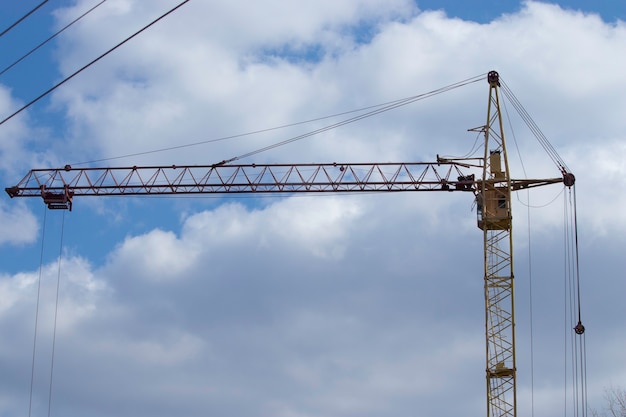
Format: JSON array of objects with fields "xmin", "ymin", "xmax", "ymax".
[{"xmin": 476, "ymin": 71, "xmax": 517, "ymax": 417}]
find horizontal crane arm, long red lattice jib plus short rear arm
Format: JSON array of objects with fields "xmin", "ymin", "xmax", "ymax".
[{"xmin": 5, "ymin": 159, "xmax": 562, "ymax": 209}]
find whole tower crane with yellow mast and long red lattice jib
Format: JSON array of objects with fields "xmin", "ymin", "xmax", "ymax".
[{"xmin": 6, "ymin": 71, "xmax": 584, "ymax": 417}]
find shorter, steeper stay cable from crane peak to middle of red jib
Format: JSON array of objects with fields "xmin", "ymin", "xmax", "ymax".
[{"xmin": 224, "ymin": 74, "xmax": 484, "ymax": 164}]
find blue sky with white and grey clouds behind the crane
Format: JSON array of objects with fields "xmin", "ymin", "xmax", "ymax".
[{"xmin": 0, "ymin": 0, "xmax": 626, "ymax": 417}]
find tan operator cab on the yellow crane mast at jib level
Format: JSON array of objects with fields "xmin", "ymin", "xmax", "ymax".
[{"xmin": 476, "ymin": 151, "xmax": 511, "ymax": 230}]
